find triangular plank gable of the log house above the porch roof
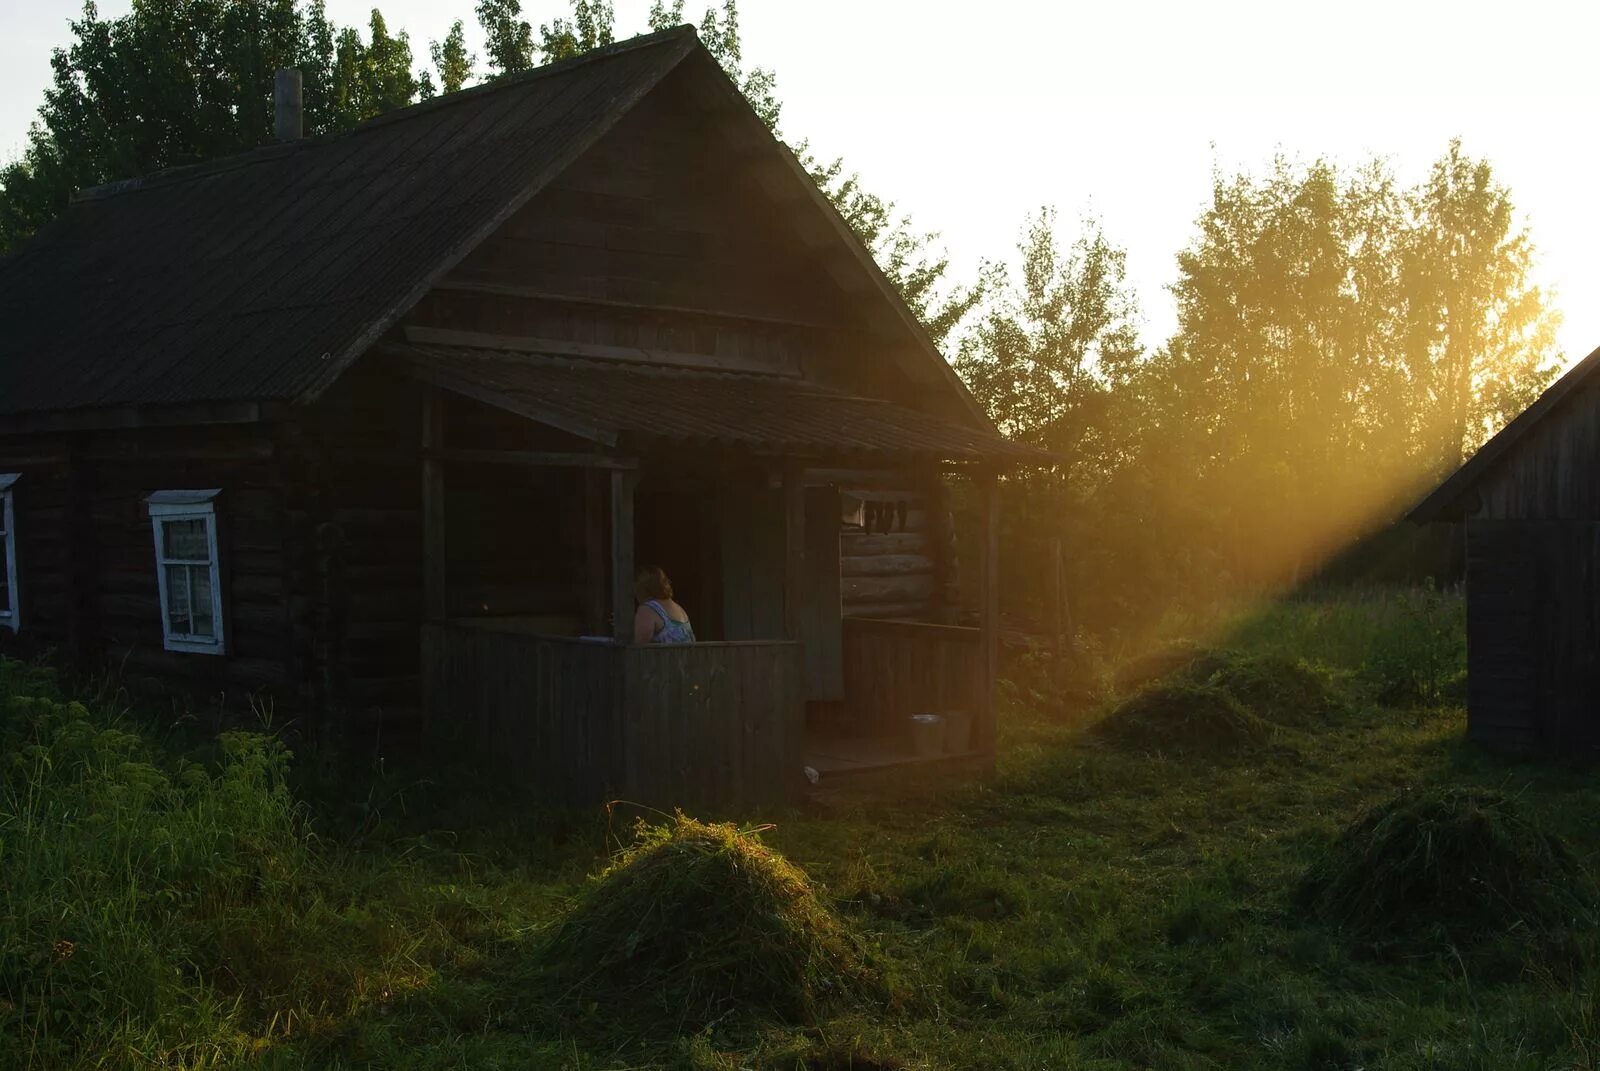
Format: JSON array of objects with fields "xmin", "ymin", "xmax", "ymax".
[{"xmin": 405, "ymin": 66, "xmax": 950, "ymax": 406}]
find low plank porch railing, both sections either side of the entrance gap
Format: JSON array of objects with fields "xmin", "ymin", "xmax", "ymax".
[{"xmin": 422, "ymin": 618, "xmax": 994, "ymax": 807}]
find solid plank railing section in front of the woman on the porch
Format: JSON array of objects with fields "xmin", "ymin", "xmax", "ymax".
[{"xmin": 422, "ymin": 623, "xmax": 805, "ymax": 807}]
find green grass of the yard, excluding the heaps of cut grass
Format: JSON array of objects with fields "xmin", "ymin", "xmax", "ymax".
[{"xmin": 0, "ymin": 594, "xmax": 1600, "ymax": 1071}]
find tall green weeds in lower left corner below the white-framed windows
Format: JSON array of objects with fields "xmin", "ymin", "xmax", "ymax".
[{"xmin": 0, "ymin": 663, "xmax": 312, "ymax": 1068}]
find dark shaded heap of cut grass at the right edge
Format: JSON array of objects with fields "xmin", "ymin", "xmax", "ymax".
[{"xmin": 1298, "ymin": 786, "xmax": 1597, "ymax": 946}]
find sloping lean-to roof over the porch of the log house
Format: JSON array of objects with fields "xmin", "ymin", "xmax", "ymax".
[{"xmin": 387, "ymin": 344, "xmax": 1054, "ymax": 464}]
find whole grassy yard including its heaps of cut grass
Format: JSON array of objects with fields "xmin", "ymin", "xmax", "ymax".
[{"xmin": 0, "ymin": 592, "xmax": 1600, "ymax": 1071}]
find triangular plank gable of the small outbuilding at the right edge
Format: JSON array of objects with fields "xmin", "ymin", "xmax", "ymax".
[{"xmin": 1469, "ymin": 384, "xmax": 1600, "ymax": 520}]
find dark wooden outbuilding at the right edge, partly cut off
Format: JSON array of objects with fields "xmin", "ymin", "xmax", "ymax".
[{"xmin": 1410, "ymin": 351, "xmax": 1600, "ymax": 754}]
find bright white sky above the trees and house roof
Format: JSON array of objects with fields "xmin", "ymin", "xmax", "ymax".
[{"xmin": 0, "ymin": 0, "xmax": 1600, "ymax": 360}]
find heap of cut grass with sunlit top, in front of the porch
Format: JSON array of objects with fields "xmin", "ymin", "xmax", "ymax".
[{"xmin": 536, "ymin": 813, "xmax": 878, "ymax": 1033}]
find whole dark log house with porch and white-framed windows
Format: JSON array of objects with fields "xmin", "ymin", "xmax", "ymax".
[{"xmin": 0, "ymin": 27, "xmax": 1037, "ymax": 804}]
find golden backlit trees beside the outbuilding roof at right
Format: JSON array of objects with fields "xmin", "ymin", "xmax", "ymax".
[{"xmin": 1152, "ymin": 142, "xmax": 1557, "ymax": 583}]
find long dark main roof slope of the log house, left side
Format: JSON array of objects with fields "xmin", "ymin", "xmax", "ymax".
[{"xmin": 0, "ymin": 29, "xmax": 699, "ymax": 415}]
